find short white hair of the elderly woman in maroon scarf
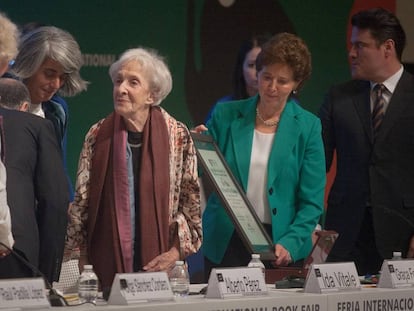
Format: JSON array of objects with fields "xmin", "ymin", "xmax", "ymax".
[{"xmin": 109, "ymin": 47, "xmax": 172, "ymax": 106}]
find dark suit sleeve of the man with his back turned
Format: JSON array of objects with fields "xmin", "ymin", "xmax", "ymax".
[{"xmin": 34, "ymin": 120, "xmax": 69, "ymax": 282}]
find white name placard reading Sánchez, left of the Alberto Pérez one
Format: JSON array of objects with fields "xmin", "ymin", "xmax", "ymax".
[{"xmin": 108, "ymin": 272, "xmax": 174, "ymax": 305}]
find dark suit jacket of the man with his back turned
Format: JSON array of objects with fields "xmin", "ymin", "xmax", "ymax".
[{"xmin": 0, "ymin": 108, "xmax": 69, "ymax": 282}]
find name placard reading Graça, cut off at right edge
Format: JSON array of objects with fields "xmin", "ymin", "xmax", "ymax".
[{"xmin": 378, "ymin": 259, "xmax": 414, "ymax": 288}]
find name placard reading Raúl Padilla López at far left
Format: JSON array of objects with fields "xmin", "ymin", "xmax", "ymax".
[{"xmin": 0, "ymin": 278, "xmax": 50, "ymax": 309}]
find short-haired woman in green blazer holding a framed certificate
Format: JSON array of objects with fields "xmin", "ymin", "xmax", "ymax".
[{"xmin": 203, "ymin": 33, "xmax": 325, "ymax": 275}]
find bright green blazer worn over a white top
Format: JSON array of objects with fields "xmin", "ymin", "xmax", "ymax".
[{"xmin": 203, "ymin": 95, "xmax": 326, "ymax": 263}]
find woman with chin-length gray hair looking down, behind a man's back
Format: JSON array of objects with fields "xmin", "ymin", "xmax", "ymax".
[{"xmin": 11, "ymin": 26, "xmax": 88, "ymax": 200}]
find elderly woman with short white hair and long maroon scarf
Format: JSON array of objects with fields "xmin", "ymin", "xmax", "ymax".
[{"xmin": 67, "ymin": 48, "xmax": 202, "ymax": 291}]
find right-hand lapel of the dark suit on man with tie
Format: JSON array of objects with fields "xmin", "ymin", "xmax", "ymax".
[{"xmin": 377, "ymin": 71, "xmax": 414, "ymax": 140}]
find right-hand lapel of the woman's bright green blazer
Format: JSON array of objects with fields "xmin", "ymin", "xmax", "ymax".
[{"xmin": 267, "ymin": 100, "xmax": 301, "ymax": 185}]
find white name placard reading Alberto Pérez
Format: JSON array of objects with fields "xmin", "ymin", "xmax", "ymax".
[{"xmin": 206, "ymin": 268, "xmax": 268, "ymax": 298}]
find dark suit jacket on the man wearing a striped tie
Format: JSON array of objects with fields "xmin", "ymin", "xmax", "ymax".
[{"xmin": 320, "ymin": 72, "xmax": 414, "ymax": 258}]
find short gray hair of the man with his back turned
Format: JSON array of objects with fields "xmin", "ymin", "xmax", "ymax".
[{"xmin": 0, "ymin": 78, "xmax": 30, "ymax": 110}]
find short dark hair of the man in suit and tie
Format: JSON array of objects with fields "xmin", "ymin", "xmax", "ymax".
[{"xmin": 351, "ymin": 8, "xmax": 406, "ymax": 61}]
